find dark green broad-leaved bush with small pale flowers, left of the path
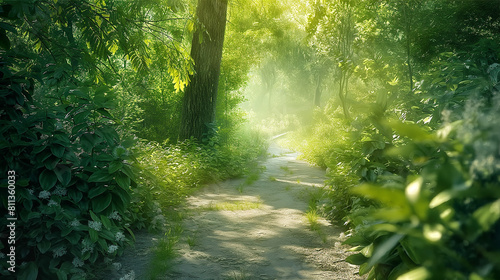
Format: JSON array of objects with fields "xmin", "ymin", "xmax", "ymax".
[{"xmin": 0, "ymin": 71, "xmax": 135, "ymax": 279}]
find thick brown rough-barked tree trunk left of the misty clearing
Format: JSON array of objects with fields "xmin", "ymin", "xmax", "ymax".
[{"xmin": 179, "ymin": 0, "xmax": 227, "ymax": 141}]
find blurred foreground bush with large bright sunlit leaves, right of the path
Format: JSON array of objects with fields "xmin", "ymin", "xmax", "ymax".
[{"xmin": 347, "ymin": 65, "xmax": 500, "ymax": 279}]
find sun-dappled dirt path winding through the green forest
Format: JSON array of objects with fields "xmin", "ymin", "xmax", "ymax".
[{"xmin": 164, "ymin": 144, "xmax": 362, "ymax": 280}]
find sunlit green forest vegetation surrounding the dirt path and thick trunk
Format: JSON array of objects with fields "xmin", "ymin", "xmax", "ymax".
[{"xmin": 0, "ymin": 0, "xmax": 500, "ymax": 280}]
